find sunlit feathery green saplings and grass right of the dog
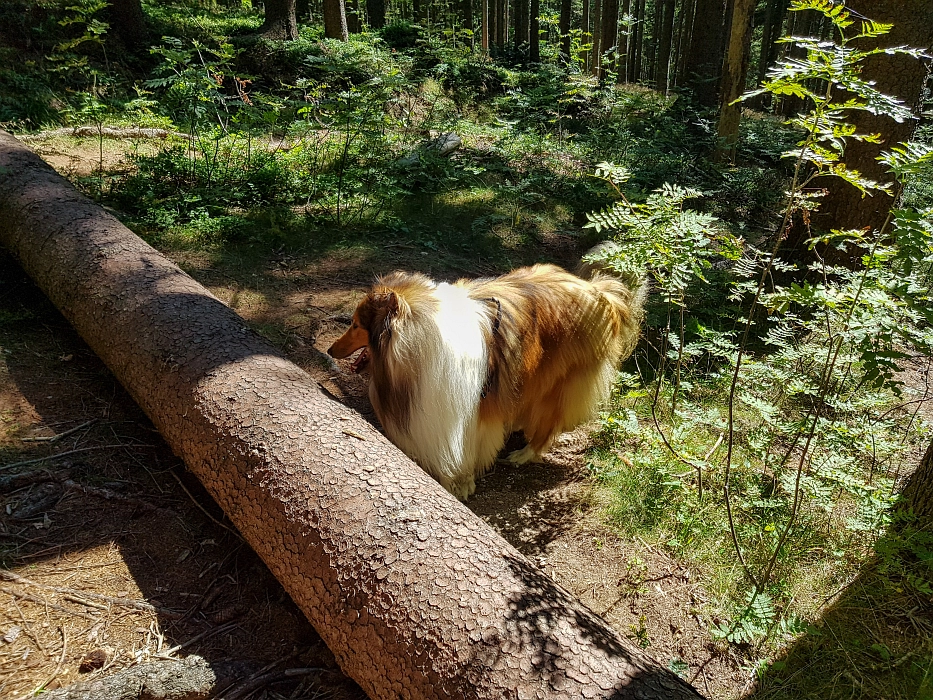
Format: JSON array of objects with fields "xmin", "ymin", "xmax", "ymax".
[{"xmin": 589, "ymin": 0, "xmax": 933, "ymax": 660}]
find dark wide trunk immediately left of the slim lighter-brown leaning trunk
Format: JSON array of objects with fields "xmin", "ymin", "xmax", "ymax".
[{"xmin": 684, "ymin": 0, "xmax": 726, "ymax": 108}]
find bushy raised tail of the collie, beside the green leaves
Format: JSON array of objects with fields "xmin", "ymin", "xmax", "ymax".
[{"xmin": 577, "ymin": 241, "xmax": 649, "ymax": 358}]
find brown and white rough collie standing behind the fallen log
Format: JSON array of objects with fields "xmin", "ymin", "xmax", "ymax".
[{"xmin": 327, "ymin": 265, "xmax": 642, "ymax": 499}]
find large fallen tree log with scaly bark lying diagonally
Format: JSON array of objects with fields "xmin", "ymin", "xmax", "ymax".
[{"xmin": 0, "ymin": 132, "xmax": 699, "ymax": 700}]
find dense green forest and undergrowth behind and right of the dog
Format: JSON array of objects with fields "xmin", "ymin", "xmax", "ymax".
[{"xmin": 0, "ymin": 0, "xmax": 933, "ymax": 698}]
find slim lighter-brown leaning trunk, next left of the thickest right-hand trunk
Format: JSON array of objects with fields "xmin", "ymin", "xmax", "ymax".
[{"xmin": 716, "ymin": 0, "xmax": 755, "ymax": 162}]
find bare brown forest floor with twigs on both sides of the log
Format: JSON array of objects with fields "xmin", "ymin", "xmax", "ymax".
[{"xmin": 0, "ymin": 133, "xmax": 924, "ymax": 699}]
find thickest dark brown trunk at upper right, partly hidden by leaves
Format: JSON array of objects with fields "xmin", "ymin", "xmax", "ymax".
[{"xmin": 813, "ymin": 0, "xmax": 933, "ymax": 249}]
